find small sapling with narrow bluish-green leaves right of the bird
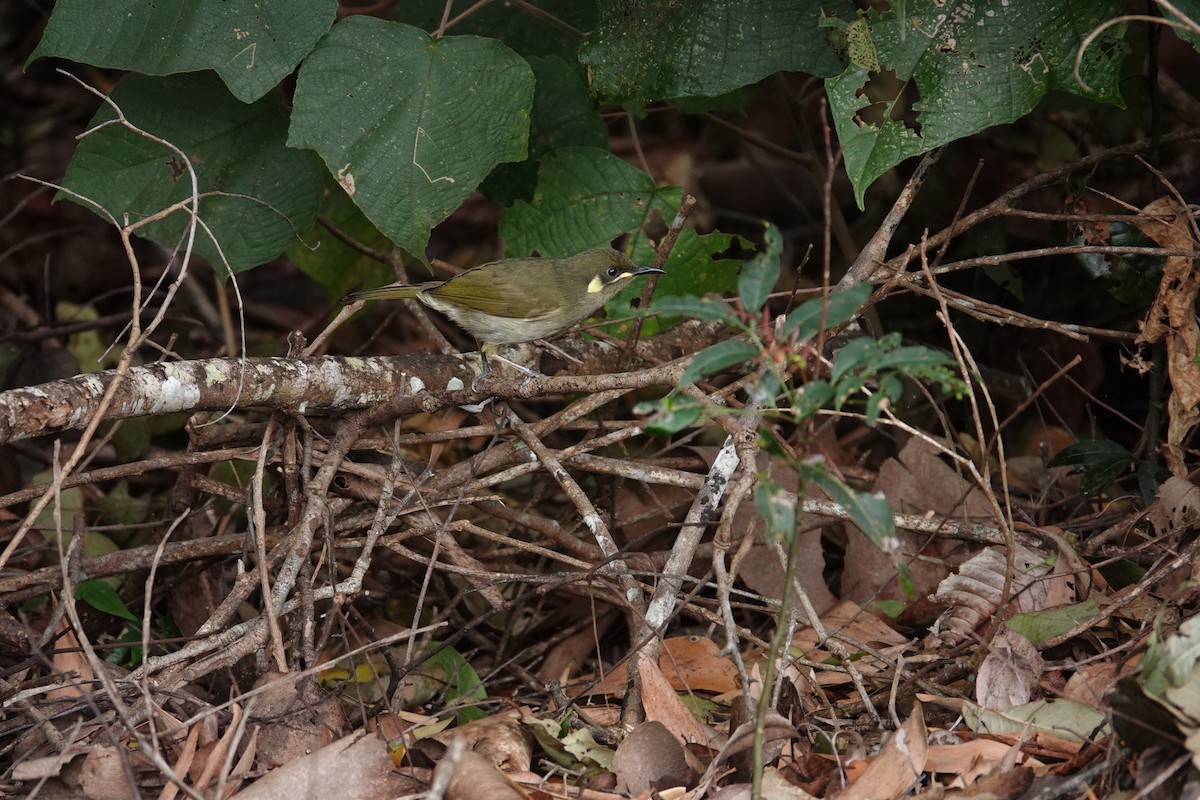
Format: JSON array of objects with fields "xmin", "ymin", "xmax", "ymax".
[{"xmin": 641, "ymin": 227, "xmax": 966, "ymax": 589}]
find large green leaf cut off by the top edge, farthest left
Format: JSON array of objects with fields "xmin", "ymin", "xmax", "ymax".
[{"xmin": 26, "ymin": 0, "xmax": 337, "ymax": 103}]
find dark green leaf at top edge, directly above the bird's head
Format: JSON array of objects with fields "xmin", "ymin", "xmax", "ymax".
[{"xmin": 580, "ymin": 0, "xmax": 853, "ymax": 103}]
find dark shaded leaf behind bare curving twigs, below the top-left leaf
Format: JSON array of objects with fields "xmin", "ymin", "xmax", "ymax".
[{"xmin": 60, "ymin": 73, "xmax": 322, "ymax": 272}]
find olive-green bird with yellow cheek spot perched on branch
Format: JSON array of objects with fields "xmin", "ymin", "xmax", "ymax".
[{"xmin": 346, "ymin": 247, "xmax": 665, "ymax": 389}]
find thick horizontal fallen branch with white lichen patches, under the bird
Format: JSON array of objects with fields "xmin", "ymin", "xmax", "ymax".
[{"xmin": 0, "ymin": 323, "xmax": 720, "ymax": 444}]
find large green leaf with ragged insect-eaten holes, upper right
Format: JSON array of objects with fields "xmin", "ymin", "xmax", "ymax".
[{"xmin": 826, "ymin": 0, "xmax": 1128, "ymax": 207}]
